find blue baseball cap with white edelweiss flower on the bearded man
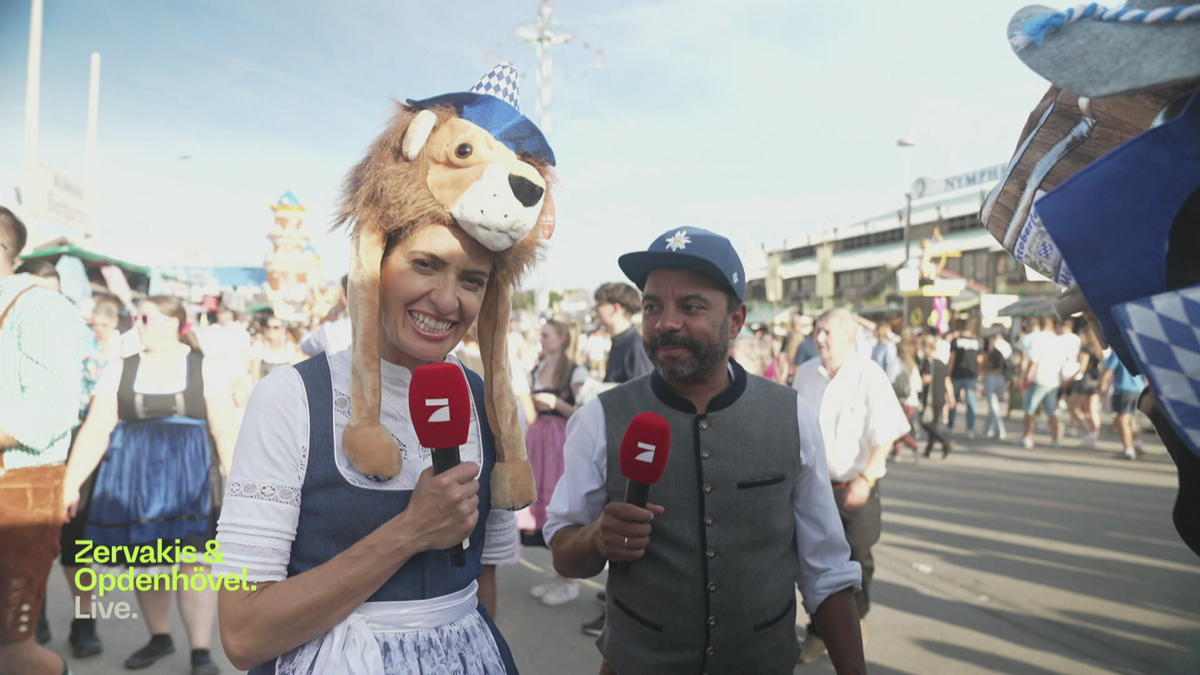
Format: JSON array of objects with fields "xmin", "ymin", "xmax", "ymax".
[{"xmin": 617, "ymin": 227, "xmax": 746, "ymax": 300}]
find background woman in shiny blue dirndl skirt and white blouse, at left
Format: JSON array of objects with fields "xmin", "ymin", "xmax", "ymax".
[{"xmin": 65, "ymin": 295, "xmax": 236, "ymax": 675}]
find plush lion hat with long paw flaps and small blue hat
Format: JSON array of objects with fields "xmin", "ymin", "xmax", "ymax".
[{"xmin": 334, "ymin": 64, "xmax": 554, "ymax": 509}]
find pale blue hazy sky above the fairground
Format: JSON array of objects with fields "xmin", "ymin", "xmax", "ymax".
[{"xmin": 0, "ymin": 0, "xmax": 1048, "ymax": 287}]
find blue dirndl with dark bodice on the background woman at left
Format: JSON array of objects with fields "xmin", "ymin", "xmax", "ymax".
[{"xmin": 84, "ymin": 352, "xmax": 223, "ymax": 554}]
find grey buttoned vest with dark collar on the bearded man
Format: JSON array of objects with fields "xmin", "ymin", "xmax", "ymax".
[{"xmin": 598, "ymin": 360, "xmax": 800, "ymax": 675}]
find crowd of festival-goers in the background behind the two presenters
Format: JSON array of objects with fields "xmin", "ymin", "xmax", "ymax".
[{"xmin": 0, "ymin": 200, "xmax": 1171, "ymax": 674}]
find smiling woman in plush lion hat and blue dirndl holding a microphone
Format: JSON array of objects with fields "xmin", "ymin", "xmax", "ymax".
[{"xmin": 215, "ymin": 64, "xmax": 554, "ymax": 675}]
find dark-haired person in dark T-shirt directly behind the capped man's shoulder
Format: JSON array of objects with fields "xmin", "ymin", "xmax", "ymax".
[{"xmin": 583, "ymin": 281, "xmax": 654, "ymax": 637}]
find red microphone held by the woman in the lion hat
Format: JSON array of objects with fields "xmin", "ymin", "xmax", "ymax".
[{"xmin": 408, "ymin": 362, "xmax": 470, "ymax": 567}]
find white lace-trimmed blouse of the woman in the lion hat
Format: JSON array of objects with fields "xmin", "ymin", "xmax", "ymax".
[{"xmin": 214, "ymin": 351, "xmax": 518, "ymax": 581}]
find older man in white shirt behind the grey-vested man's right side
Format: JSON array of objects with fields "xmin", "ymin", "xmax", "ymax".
[{"xmin": 792, "ymin": 309, "xmax": 911, "ymax": 663}]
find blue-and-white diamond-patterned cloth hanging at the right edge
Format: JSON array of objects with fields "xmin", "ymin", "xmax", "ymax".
[{"xmin": 1112, "ymin": 286, "xmax": 1200, "ymax": 454}]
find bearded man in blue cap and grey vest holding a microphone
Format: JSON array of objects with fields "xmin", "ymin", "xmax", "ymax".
[{"xmin": 542, "ymin": 228, "xmax": 865, "ymax": 675}]
